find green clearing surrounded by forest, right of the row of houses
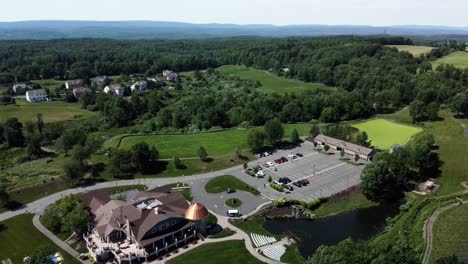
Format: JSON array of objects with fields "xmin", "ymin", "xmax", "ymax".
[{"xmin": 217, "ymin": 65, "xmax": 331, "ymax": 94}]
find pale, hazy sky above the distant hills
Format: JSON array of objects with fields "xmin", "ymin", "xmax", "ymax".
[{"xmin": 0, "ymin": 0, "xmax": 468, "ymax": 27}]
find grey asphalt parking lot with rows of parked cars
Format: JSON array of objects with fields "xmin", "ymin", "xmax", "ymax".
[{"xmin": 245, "ymin": 142, "xmax": 367, "ymax": 201}]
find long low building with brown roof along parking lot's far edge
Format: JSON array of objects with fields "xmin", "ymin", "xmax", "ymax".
[{"xmin": 308, "ymin": 134, "xmax": 377, "ymax": 160}]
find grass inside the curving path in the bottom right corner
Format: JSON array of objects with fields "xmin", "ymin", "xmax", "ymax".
[{"xmin": 431, "ymin": 204, "xmax": 468, "ymax": 263}]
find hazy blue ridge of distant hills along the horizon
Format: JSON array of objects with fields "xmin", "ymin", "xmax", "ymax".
[{"xmin": 0, "ymin": 21, "xmax": 468, "ymax": 40}]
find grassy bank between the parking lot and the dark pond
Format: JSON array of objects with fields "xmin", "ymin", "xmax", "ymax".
[{"xmin": 314, "ymin": 192, "xmax": 377, "ymax": 217}]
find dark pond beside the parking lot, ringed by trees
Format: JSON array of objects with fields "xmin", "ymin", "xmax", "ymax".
[{"xmin": 264, "ymin": 206, "xmax": 396, "ymax": 258}]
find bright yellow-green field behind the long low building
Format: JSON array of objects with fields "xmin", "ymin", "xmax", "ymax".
[{"xmin": 353, "ymin": 119, "xmax": 422, "ymax": 149}]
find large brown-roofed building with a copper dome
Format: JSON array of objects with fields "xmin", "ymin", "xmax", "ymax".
[{"xmin": 81, "ymin": 186, "xmax": 209, "ymax": 263}]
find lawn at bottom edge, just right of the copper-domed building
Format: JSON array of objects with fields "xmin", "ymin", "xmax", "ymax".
[{"xmin": 167, "ymin": 240, "xmax": 262, "ymax": 264}]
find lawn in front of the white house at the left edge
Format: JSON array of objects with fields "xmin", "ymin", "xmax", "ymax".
[{"xmin": 0, "ymin": 99, "xmax": 97, "ymax": 123}]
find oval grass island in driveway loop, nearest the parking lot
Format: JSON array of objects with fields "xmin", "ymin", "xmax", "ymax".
[{"xmin": 205, "ymin": 175, "xmax": 260, "ymax": 195}]
